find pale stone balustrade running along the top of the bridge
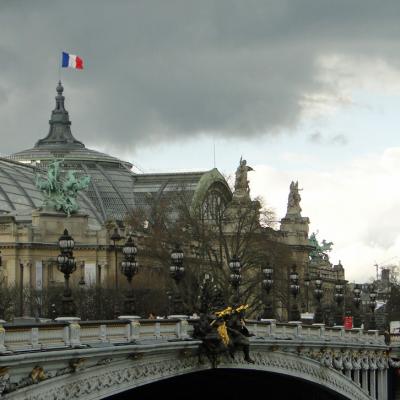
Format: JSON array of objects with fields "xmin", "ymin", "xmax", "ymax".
[{"xmin": 0, "ymin": 318, "xmax": 385, "ymax": 354}]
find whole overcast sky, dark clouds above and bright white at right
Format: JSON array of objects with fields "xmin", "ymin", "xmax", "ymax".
[{"xmin": 0, "ymin": 0, "xmax": 400, "ymax": 280}]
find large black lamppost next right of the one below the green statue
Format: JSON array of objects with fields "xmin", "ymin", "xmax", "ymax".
[{"xmin": 121, "ymin": 235, "xmax": 139, "ymax": 315}]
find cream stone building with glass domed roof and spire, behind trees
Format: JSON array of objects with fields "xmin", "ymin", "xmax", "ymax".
[{"xmin": 0, "ymin": 82, "xmax": 344, "ymax": 320}]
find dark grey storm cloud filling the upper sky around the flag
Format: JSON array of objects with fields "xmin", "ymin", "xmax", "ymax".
[{"xmin": 0, "ymin": 0, "xmax": 400, "ymax": 154}]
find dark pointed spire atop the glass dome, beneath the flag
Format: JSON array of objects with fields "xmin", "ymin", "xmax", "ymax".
[{"xmin": 35, "ymin": 81, "xmax": 85, "ymax": 148}]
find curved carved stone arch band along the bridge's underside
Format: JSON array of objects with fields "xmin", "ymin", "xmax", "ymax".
[{"xmin": 5, "ymin": 345, "xmax": 371, "ymax": 400}]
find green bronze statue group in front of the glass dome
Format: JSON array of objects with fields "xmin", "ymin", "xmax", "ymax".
[{"xmin": 36, "ymin": 160, "xmax": 90, "ymax": 216}]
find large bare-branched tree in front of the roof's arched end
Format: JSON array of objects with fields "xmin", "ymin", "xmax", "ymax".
[{"xmin": 126, "ymin": 185, "xmax": 290, "ymax": 316}]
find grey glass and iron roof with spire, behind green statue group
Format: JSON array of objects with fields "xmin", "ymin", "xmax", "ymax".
[{"xmin": 0, "ymin": 82, "xmax": 231, "ymax": 224}]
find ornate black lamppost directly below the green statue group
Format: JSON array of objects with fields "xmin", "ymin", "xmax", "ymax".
[{"xmin": 57, "ymin": 229, "xmax": 76, "ymax": 316}]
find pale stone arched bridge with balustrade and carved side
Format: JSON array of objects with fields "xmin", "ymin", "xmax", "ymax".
[{"xmin": 0, "ymin": 317, "xmax": 397, "ymax": 400}]
